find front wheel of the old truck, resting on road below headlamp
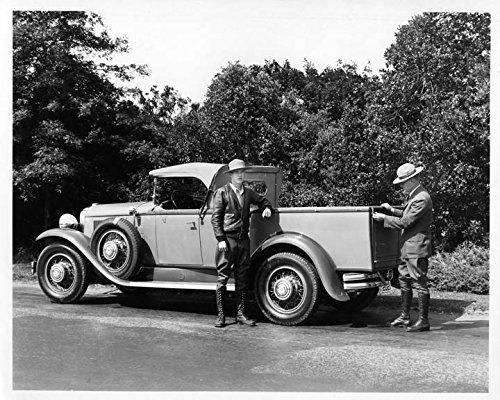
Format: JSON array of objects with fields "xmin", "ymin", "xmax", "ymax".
[{"xmin": 37, "ymin": 243, "xmax": 89, "ymax": 303}]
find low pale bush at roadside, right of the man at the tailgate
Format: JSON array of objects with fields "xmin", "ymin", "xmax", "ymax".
[{"xmin": 428, "ymin": 242, "xmax": 490, "ymax": 294}]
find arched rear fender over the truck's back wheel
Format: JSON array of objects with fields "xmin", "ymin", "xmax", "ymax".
[{"xmin": 252, "ymin": 232, "xmax": 349, "ymax": 301}]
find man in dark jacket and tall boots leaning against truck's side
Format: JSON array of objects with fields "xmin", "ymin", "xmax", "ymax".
[{"xmin": 212, "ymin": 159, "xmax": 272, "ymax": 328}]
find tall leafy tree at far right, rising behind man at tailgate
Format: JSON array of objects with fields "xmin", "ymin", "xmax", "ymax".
[{"xmin": 368, "ymin": 13, "xmax": 490, "ymax": 250}]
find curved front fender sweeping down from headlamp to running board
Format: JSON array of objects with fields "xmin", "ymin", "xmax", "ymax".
[{"xmin": 36, "ymin": 228, "xmax": 132, "ymax": 286}]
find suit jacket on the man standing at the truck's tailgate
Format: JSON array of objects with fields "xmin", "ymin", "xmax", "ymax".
[{"xmin": 384, "ymin": 186, "xmax": 433, "ymax": 258}]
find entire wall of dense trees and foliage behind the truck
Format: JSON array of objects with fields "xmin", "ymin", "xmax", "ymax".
[{"xmin": 13, "ymin": 12, "xmax": 490, "ymax": 260}]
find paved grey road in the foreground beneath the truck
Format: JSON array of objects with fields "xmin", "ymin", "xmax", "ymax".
[{"xmin": 13, "ymin": 285, "xmax": 488, "ymax": 392}]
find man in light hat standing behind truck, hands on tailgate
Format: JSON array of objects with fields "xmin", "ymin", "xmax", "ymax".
[{"xmin": 373, "ymin": 163, "xmax": 433, "ymax": 332}]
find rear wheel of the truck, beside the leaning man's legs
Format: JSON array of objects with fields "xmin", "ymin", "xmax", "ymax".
[{"xmin": 254, "ymin": 253, "xmax": 320, "ymax": 325}]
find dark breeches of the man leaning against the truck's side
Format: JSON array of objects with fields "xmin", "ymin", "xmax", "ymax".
[{"xmin": 215, "ymin": 237, "xmax": 250, "ymax": 291}]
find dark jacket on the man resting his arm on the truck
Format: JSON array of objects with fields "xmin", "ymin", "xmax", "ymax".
[{"xmin": 212, "ymin": 183, "xmax": 272, "ymax": 241}]
